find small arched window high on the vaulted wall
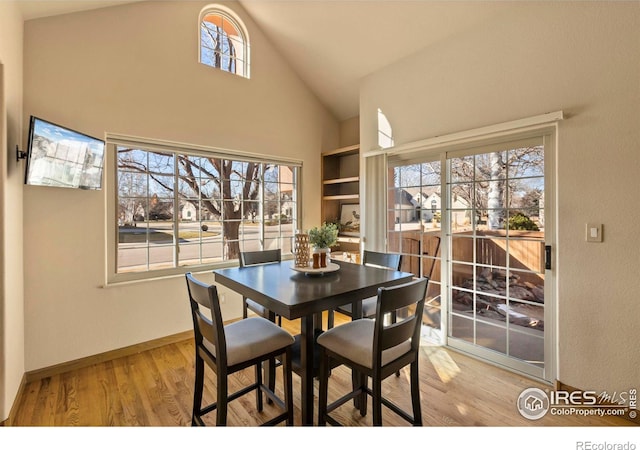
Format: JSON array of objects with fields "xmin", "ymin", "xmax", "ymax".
[{"xmin": 200, "ymin": 5, "xmax": 249, "ymax": 78}]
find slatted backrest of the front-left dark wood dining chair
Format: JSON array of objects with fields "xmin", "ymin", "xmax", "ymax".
[{"xmin": 186, "ymin": 272, "xmax": 227, "ymax": 364}]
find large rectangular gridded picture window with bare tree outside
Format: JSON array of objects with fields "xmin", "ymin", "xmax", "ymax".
[{"xmin": 107, "ymin": 137, "xmax": 299, "ymax": 278}]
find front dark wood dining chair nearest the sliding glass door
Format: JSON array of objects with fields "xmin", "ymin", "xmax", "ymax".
[{"xmin": 317, "ymin": 278, "xmax": 429, "ymax": 426}]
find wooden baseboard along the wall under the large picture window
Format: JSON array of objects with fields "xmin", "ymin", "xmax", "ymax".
[{"xmin": 25, "ymin": 330, "xmax": 193, "ymax": 384}]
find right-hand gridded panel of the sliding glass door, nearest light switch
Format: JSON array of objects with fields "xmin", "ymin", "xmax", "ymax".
[{"xmin": 446, "ymin": 138, "xmax": 546, "ymax": 376}]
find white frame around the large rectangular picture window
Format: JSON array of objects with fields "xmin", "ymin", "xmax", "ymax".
[{"xmin": 105, "ymin": 133, "xmax": 303, "ymax": 286}]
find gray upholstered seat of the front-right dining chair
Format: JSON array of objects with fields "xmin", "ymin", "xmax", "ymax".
[{"xmin": 318, "ymin": 319, "xmax": 411, "ymax": 369}]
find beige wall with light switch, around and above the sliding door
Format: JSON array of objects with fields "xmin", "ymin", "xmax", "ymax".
[{"xmin": 360, "ymin": 2, "xmax": 640, "ymax": 392}]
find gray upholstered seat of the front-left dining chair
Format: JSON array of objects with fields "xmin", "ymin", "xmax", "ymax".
[{"xmin": 203, "ymin": 317, "xmax": 295, "ymax": 366}]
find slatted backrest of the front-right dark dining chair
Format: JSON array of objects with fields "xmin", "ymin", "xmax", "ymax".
[{"xmin": 373, "ymin": 278, "xmax": 429, "ymax": 367}]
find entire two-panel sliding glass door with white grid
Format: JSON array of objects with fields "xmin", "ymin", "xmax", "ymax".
[{"xmin": 387, "ymin": 135, "xmax": 553, "ymax": 378}]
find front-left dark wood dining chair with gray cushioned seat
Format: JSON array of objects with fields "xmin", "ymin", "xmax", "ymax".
[{"xmin": 186, "ymin": 272, "xmax": 295, "ymax": 426}]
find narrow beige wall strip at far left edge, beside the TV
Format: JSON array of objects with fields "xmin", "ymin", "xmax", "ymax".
[{"xmin": 0, "ymin": 2, "xmax": 25, "ymax": 422}]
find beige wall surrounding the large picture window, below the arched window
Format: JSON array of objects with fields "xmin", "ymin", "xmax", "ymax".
[{"xmin": 24, "ymin": 1, "xmax": 339, "ymax": 371}]
